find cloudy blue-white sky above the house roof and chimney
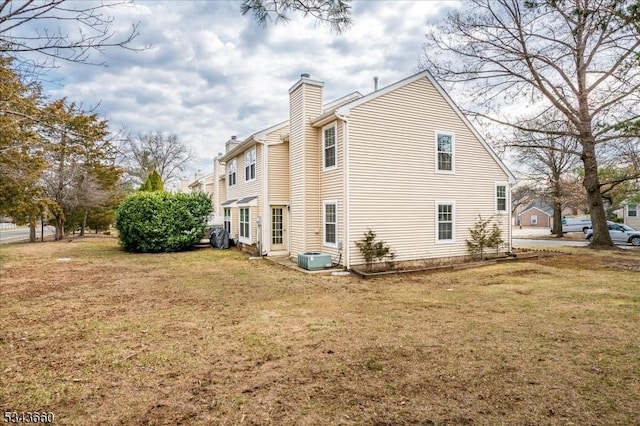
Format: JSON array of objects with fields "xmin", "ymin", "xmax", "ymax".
[{"xmin": 41, "ymin": 0, "xmax": 456, "ymax": 183}]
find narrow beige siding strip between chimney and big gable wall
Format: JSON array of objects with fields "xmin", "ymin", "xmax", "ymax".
[{"xmin": 316, "ymin": 120, "xmax": 345, "ymax": 261}]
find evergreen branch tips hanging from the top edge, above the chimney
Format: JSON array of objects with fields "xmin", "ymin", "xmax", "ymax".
[{"xmin": 240, "ymin": 0, "xmax": 352, "ymax": 33}]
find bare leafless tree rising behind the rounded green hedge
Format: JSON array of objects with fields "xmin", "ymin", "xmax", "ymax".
[{"xmin": 120, "ymin": 132, "xmax": 194, "ymax": 185}]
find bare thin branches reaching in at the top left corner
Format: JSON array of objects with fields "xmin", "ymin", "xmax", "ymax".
[{"xmin": 0, "ymin": 0, "xmax": 145, "ymax": 72}]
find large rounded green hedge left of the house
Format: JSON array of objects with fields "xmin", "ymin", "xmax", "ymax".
[{"xmin": 116, "ymin": 191, "xmax": 211, "ymax": 253}]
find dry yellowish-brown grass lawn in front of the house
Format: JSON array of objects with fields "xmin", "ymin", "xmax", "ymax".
[{"xmin": 0, "ymin": 236, "xmax": 640, "ymax": 426}]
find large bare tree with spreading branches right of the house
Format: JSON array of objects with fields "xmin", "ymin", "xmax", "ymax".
[{"xmin": 421, "ymin": 0, "xmax": 640, "ymax": 246}]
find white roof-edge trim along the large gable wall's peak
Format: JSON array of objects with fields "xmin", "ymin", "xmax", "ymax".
[{"xmin": 336, "ymin": 70, "xmax": 516, "ymax": 183}]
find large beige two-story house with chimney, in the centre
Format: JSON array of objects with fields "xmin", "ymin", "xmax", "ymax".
[{"xmin": 217, "ymin": 71, "xmax": 515, "ymax": 268}]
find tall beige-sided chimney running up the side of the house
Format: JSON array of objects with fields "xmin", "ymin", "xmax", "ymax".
[{"xmin": 289, "ymin": 84, "xmax": 322, "ymax": 257}]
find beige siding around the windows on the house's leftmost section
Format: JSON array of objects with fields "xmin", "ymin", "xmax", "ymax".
[{"xmin": 225, "ymin": 144, "xmax": 263, "ymax": 244}]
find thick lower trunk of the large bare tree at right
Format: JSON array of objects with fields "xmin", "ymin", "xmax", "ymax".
[{"xmin": 580, "ymin": 139, "xmax": 613, "ymax": 247}]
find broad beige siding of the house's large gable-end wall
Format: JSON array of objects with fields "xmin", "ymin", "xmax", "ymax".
[{"xmin": 349, "ymin": 78, "xmax": 510, "ymax": 264}]
